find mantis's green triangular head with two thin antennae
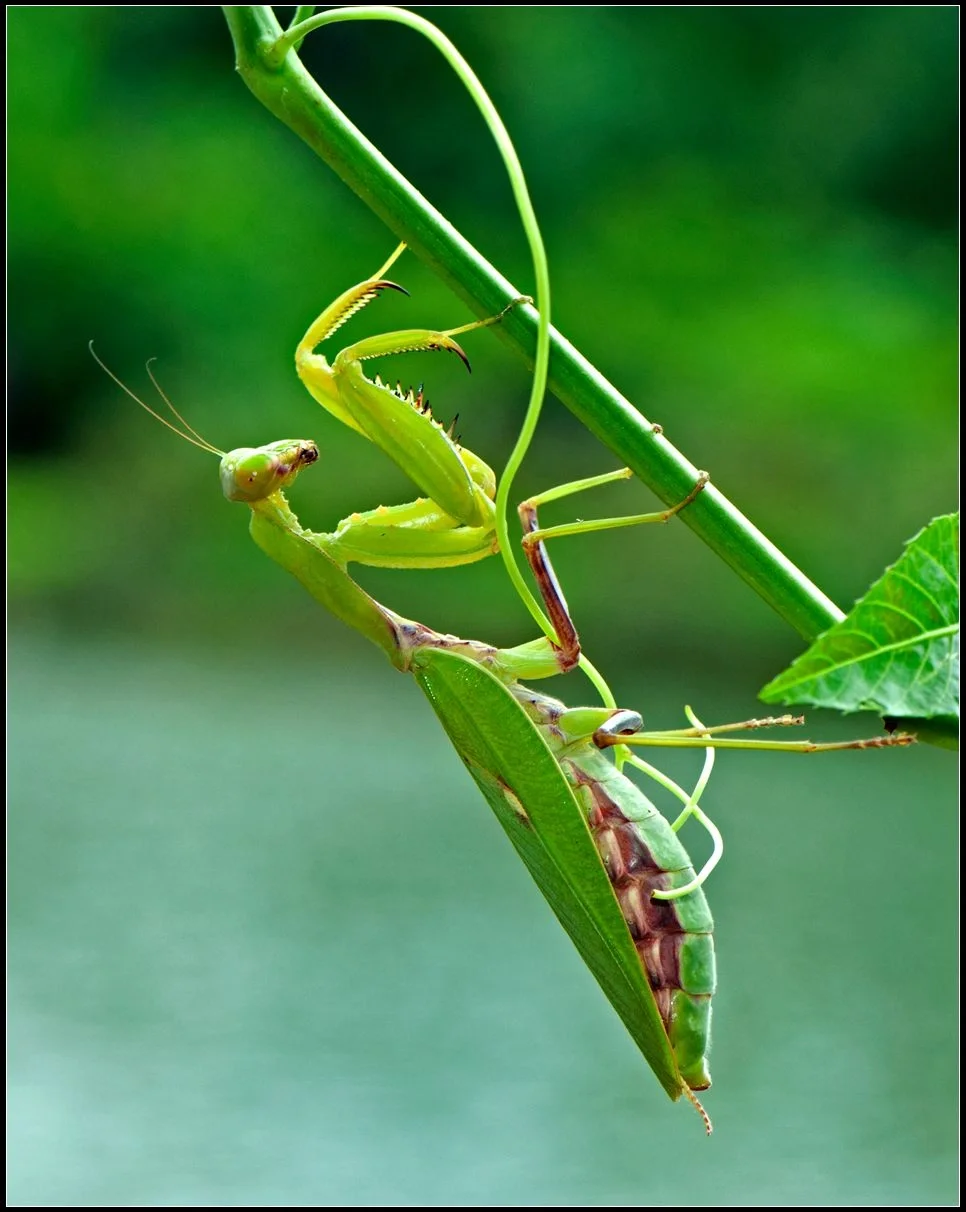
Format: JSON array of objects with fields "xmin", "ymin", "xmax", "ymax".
[{"xmin": 90, "ymin": 342, "xmax": 319, "ymax": 504}]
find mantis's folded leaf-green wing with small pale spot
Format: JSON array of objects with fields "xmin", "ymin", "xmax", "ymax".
[{"xmin": 413, "ymin": 648, "xmax": 685, "ymax": 1099}]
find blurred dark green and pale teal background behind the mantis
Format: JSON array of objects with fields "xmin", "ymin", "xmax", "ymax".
[{"xmin": 8, "ymin": 6, "xmax": 958, "ymax": 1206}]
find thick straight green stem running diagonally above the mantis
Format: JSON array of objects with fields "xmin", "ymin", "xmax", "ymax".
[{"xmin": 224, "ymin": 5, "xmax": 844, "ymax": 640}]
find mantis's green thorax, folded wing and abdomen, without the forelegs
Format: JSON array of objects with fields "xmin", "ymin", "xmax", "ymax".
[{"xmin": 237, "ymin": 442, "xmax": 715, "ymax": 1102}]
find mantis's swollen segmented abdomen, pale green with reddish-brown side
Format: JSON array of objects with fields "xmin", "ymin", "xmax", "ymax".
[{"xmin": 561, "ymin": 755, "xmax": 715, "ymax": 1090}]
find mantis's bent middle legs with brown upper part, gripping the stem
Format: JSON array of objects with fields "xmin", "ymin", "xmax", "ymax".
[{"xmin": 518, "ymin": 468, "xmax": 709, "ymax": 671}]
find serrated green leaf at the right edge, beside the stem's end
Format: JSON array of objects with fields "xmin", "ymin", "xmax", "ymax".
[{"xmin": 761, "ymin": 514, "xmax": 959, "ymax": 731}]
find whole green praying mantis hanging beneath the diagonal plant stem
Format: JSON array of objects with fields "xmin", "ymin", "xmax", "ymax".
[{"xmin": 90, "ymin": 248, "xmax": 911, "ymax": 1130}]
